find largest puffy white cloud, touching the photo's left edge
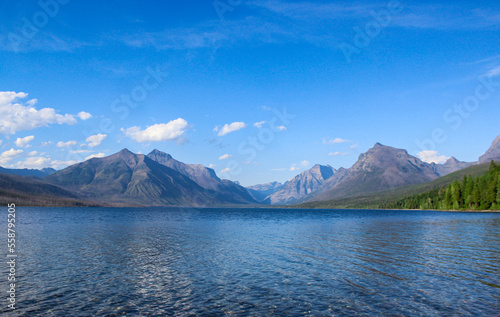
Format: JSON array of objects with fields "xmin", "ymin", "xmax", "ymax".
[{"xmin": 0, "ymin": 91, "xmax": 76, "ymax": 134}]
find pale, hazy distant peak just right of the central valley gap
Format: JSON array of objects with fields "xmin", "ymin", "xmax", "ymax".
[{"xmin": 264, "ymin": 164, "xmax": 337, "ymax": 205}]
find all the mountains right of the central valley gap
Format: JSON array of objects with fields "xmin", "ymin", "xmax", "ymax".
[{"xmin": 248, "ymin": 136, "xmax": 500, "ymax": 205}]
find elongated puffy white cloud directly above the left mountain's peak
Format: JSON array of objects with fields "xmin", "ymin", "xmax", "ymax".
[{"xmin": 121, "ymin": 118, "xmax": 189, "ymax": 143}]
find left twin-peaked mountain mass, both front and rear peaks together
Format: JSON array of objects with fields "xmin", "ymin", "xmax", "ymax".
[{"xmin": 45, "ymin": 149, "xmax": 256, "ymax": 206}]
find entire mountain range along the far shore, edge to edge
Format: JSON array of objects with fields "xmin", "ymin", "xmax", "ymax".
[{"xmin": 0, "ymin": 136, "xmax": 500, "ymax": 206}]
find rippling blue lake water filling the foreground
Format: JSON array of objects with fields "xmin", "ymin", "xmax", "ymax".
[{"xmin": 0, "ymin": 207, "xmax": 500, "ymax": 316}]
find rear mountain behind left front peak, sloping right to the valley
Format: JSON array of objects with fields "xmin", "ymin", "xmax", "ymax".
[{"xmin": 147, "ymin": 149, "xmax": 257, "ymax": 204}]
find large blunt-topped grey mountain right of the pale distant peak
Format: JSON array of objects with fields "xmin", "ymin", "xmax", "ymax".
[{"xmin": 309, "ymin": 143, "xmax": 439, "ymax": 201}]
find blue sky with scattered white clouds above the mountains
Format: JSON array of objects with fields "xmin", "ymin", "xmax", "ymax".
[{"xmin": 0, "ymin": 0, "xmax": 500, "ymax": 185}]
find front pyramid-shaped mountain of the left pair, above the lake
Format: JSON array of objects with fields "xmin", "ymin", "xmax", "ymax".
[{"xmin": 45, "ymin": 149, "xmax": 231, "ymax": 206}]
